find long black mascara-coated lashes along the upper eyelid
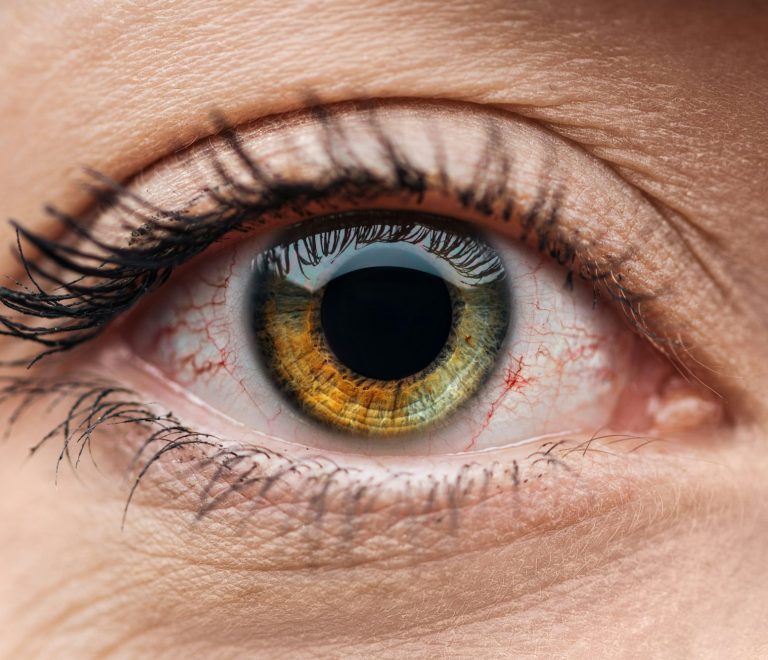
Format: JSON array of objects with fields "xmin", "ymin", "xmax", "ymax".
[{"xmin": 0, "ymin": 106, "xmax": 662, "ymax": 364}]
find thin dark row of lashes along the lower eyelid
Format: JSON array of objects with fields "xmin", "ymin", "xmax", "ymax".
[{"xmin": 0, "ymin": 377, "xmax": 659, "ymax": 526}]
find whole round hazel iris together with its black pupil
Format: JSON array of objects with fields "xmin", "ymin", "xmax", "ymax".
[{"xmin": 251, "ymin": 211, "xmax": 510, "ymax": 436}]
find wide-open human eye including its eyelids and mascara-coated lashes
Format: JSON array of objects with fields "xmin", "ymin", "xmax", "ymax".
[{"xmin": 3, "ymin": 103, "xmax": 724, "ymax": 532}]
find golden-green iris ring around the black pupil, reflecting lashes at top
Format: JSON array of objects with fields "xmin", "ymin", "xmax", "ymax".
[{"xmin": 252, "ymin": 212, "xmax": 509, "ymax": 436}]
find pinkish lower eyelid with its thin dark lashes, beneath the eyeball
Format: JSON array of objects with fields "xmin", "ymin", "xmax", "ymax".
[{"xmin": 6, "ymin": 366, "xmax": 728, "ymax": 562}]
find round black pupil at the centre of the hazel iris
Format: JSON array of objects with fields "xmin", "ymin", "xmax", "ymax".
[{"xmin": 320, "ymin": 266, "xmax": 453, "ymax": 380}]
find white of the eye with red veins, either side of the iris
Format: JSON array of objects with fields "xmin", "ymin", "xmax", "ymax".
[{"xmin": 135, "ymin": 227, "xmax": 631, "ymax": 454}]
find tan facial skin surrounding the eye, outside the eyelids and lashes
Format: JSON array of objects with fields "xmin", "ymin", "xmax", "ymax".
[{"xmin": 0, "ymin": 0, "xmax": 768, "ymax": 658}]
